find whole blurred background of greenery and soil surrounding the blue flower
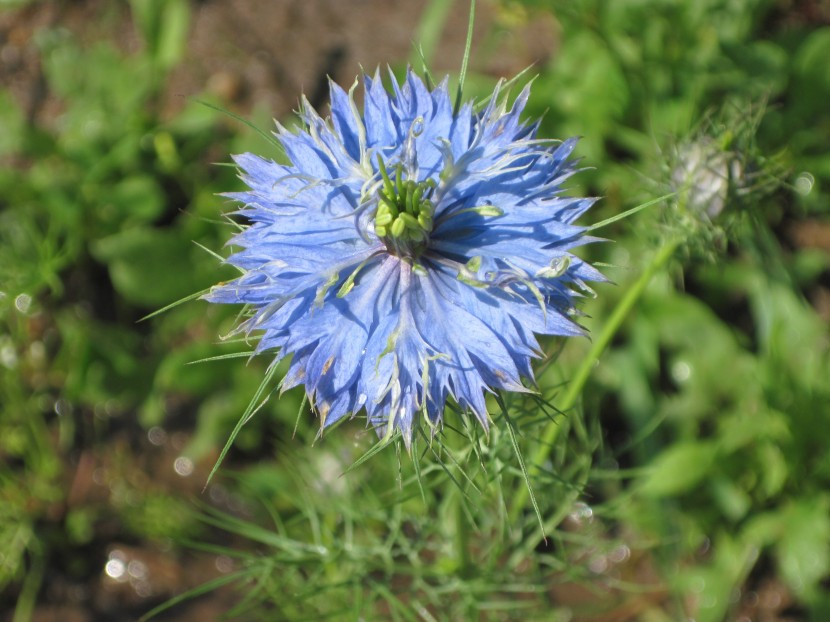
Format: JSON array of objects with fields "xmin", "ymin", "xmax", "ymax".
[{"xmin": 0, "ymin": 0, "xmax": 830, "ymax": 622}]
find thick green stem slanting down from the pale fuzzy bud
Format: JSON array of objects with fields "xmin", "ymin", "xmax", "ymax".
[{"xmin": 510, "ymin": 239, "xmax": 681, "ymax": 524}]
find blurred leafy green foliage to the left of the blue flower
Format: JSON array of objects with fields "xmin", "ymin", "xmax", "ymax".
[{"xmin": 0, "ymin": 1, "xmax": 282, "ymax": 619}]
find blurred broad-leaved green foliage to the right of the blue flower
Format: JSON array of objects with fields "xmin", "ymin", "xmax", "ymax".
[{"xmin": 508, "ymin": 0, "xmax": 830, "ymax": 621}]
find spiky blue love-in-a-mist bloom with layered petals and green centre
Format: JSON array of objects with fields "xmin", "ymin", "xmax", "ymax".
[{"xmin": 206, "ymin": 71, "xmax": 602, "ymax": 445}]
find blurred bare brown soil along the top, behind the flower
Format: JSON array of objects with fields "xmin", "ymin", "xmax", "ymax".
[{"xmin": 0, "ymin": 0, "xmax": 557, "ymax": 127}]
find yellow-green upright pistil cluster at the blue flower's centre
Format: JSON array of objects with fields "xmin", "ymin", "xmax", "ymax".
[{"xmin": 375, "ymin": 156, "xmax": 435, "ymax": 257}]
